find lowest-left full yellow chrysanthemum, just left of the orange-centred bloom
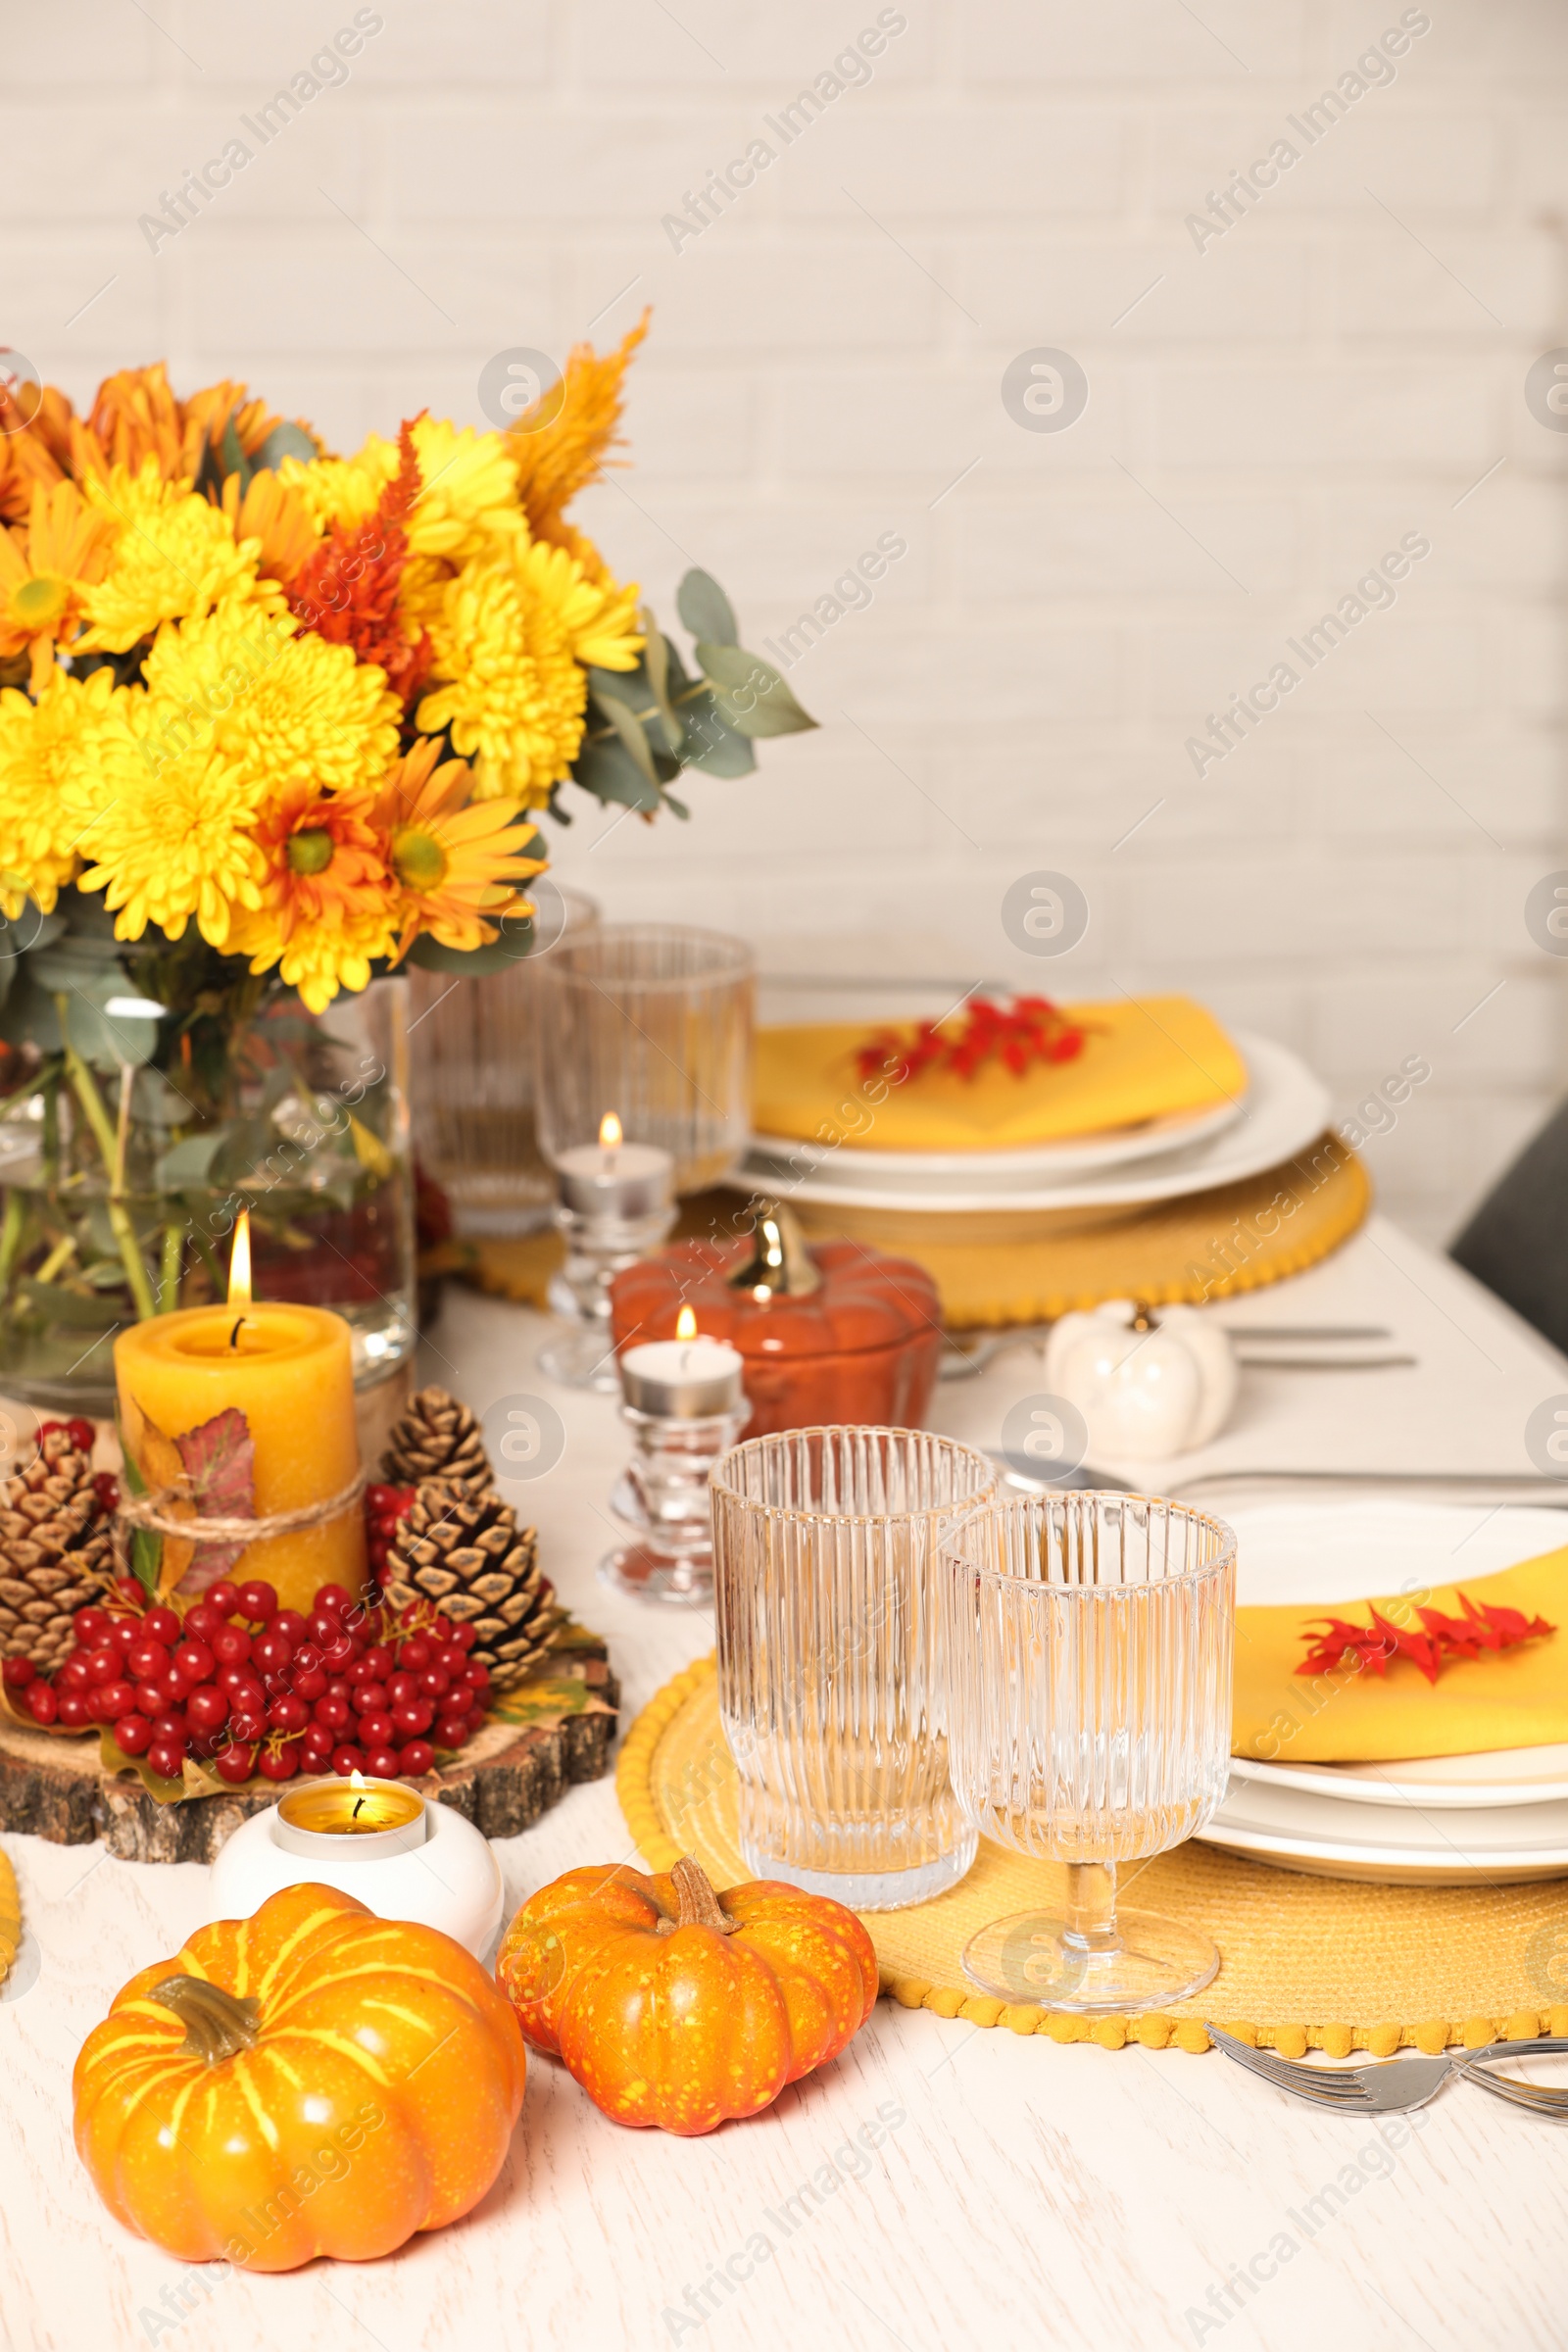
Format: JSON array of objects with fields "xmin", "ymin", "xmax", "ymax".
[{"xmin": 80, "ymin": 755, "xmax": 266, "ymax": 948}]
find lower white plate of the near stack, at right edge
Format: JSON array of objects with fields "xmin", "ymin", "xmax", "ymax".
[{"xmin": 1197, "ymin": 1776, "xmax": 1568, "ymax": 1886}]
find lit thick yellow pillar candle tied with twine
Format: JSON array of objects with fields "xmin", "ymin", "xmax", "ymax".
[{"xmin": 116, "ymin": 1298, "xmax": 365, "ymax": 1613}]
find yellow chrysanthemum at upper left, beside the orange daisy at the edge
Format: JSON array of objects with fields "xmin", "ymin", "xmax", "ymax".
[{"xmin": 80, "ymin": 459, "xmax": 282, "ymax": 654}]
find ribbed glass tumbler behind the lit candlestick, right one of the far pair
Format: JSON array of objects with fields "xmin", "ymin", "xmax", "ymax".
[{"xmin": 536, "ymin": 922, "xmax": 753, "ymax": 1193}]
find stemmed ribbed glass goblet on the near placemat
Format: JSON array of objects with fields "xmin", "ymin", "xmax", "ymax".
[{"xmin": 941, "ymin": 1492, "xmax": 1237, "ymax": 2011}]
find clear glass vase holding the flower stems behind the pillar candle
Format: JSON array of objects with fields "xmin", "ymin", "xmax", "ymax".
[{"xmin": 0, "ymin": 978, "xmax": 416, "ymax": 1416}]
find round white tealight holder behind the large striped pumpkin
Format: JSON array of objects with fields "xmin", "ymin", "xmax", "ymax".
[{"xmin": 209, "ymin": 1778, "xmax": 506, "ymax": 1959}]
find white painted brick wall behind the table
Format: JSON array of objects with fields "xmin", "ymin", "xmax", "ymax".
[{"xmin": 12, "ymin": 0, "xmax": 1568, "ymax": 1235}]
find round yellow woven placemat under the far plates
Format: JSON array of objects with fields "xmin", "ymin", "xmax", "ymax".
[{"xmin": 792, "ymin": 1136, "xmax": 1373, "ymax": 1329}]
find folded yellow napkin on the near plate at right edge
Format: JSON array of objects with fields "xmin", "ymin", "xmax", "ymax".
[{"xmin": 1230, "ymin": 1545, "xmax": 1568, "ymax": 1764}]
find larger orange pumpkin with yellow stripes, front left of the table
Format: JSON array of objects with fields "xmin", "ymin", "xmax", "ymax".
[{"xmin": 73, "ymin": 1886, "xmax": 526, "ymax": 2270}]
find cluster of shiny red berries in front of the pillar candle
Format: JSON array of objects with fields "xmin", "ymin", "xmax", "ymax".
[{"xmin": 5, "ymin": 1578, "xmax": 489, "ymax": 1786}]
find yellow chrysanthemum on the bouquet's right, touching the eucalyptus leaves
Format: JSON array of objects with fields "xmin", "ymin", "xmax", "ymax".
[{"xmin": 418, "ymin": 536, "xmax": 642, "ymax": 809}]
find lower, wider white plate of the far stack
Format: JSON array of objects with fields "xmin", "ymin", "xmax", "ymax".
[{"xmin": 724, "ymin": 1030, "xmax": 1328, "ymax": 1213}]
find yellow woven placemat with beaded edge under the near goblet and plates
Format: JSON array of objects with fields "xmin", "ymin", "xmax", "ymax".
[{"xmin": 615, "ymin": 1658, "xmax": 1568, "ymax": 2058}]
